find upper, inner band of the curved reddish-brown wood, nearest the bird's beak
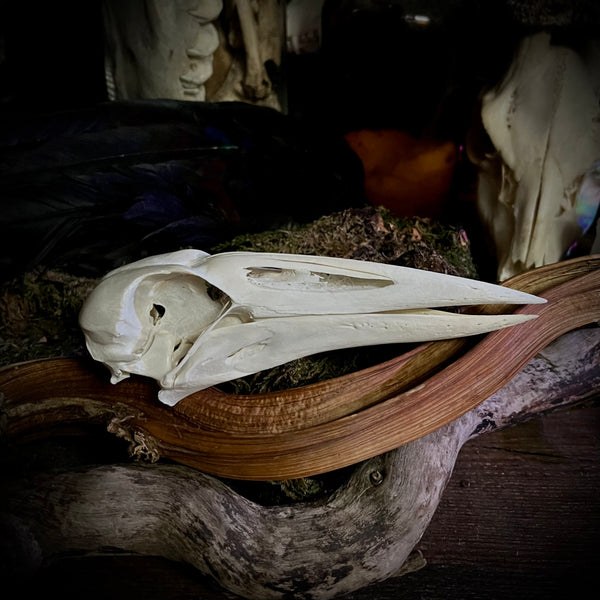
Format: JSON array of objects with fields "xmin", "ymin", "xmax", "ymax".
[{"xmin": 0, "ymin": 257, "xmax": 600, "ymax": 435}]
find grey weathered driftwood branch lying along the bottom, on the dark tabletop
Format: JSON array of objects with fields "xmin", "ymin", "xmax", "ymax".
[{"xmin": 3, "ymin": 329, "xmax": 600, "ymax": 599}]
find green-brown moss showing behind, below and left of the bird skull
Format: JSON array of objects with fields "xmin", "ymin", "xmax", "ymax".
[{"xmin": 0, "ymin": 208, "xmax": 477, "ymax": 504}]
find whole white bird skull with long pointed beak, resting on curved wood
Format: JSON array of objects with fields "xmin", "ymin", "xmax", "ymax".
[{"xmin": 80, "ymin": 250, "xmax": 545, "ymax": 405}]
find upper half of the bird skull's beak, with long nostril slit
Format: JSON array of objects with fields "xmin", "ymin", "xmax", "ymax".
[{"xmin": 198, "ymin": 252, "xmax": 546, "ymax": 318}]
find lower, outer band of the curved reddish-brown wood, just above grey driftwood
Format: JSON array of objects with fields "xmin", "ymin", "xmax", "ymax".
[{"xmin": 0, "ymin": 262, "xmax": 600, "ymax": 480}]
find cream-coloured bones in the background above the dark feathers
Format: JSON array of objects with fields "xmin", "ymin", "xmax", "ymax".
[{"xmin": 103, "ymin": 0, "xmax": 285, "ymax": 110}]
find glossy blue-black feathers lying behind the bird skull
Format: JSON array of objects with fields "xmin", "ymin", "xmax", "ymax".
[{"xmin": 0, "ymin": 101, "xmax": 364, "ymax": 277}]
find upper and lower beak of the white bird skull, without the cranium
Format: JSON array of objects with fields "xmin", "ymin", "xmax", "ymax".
[{"xmin": 159, "ymin": 253, "xmax": 546, "ymax": 404}]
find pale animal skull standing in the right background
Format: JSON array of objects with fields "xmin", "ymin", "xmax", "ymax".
[{"xmin": 469, "ymin": 33, "xmax": 600, "ymax": 281}]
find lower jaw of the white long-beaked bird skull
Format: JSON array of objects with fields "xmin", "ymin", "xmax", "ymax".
[{"xmin": 159, "ymin": 310, "xmax": 536, "ymax": 405}]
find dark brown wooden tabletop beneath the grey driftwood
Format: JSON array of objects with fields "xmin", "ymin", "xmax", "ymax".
[{"xmin": 11, "ymin": 403, "xmax": 600, "ymax": 600}]
